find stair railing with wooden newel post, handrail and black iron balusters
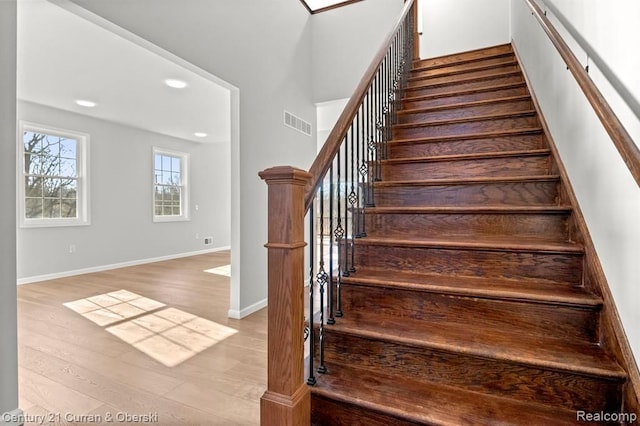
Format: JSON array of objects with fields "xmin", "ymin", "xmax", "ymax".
[{"xmin": 260, "ymin": 0, "xmax": 419, "ymax": 426}]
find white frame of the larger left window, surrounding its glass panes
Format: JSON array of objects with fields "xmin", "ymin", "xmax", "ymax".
[{"xmin": 17, "ymin": 120, "xmax": 91, "ymax": 228}]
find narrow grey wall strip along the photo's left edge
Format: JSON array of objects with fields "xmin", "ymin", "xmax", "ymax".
[{"xmin": 0, "ymin": 0, "xmax": 18, "ymax": 424}]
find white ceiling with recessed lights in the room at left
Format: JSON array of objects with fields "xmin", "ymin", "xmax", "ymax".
[{"xmin": 18, "ymin": 0, "xmax": 231, "ymax": 143}]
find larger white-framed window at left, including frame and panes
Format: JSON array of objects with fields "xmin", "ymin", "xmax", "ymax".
[{"xmin": 18, "ymin": 122, "xmax": 89, "ymax": 227}]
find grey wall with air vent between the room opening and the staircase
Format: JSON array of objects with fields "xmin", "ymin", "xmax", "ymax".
[{"xmin": 67, "ymin": 0, "xmax": 316, "ymax": 316}]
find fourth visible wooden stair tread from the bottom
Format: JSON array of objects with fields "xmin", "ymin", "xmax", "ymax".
[{"xmin": 355, "ymin": 236, "xmax": 584, "ymax": 253}]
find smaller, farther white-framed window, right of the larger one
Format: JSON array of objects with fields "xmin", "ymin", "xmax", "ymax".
[{"xmin": 153, "ymin": 148, "xmax": 189, "ymax": 222}]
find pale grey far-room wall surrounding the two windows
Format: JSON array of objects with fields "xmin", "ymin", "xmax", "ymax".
[{"xmin": 14, "ymin": 102, "xmax": 231, "ymax": 282}]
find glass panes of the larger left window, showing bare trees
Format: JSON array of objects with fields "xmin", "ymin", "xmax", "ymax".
[{"xmin": 23, "ymin": 130, "xmax": 78, "ymax": 219}]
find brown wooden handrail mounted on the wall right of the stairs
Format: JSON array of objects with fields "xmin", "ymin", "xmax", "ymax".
[{"xmin": 525, "ymin": 0, "xmax": 640, "ymax": 186}]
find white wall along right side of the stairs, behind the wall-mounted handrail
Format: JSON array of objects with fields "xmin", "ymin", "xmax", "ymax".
[{"xmin": 511, "ymin": 0, "xmax": 640, "ymax": 359}]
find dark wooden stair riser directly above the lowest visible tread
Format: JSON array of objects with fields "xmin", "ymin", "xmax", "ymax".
[{"xmin": 325, "ymin": 327, "xmax": 621, "ymax": 412}]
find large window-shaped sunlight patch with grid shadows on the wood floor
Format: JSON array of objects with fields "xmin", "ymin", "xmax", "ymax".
[{"xmin": 63, "ymin": 290, "xmax": 238, "ymax": 367}]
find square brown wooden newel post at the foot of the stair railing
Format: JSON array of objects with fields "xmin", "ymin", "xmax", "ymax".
[{"xmin": 259, "ymin": 166, "xmax": 311, "ymax": 426}]
